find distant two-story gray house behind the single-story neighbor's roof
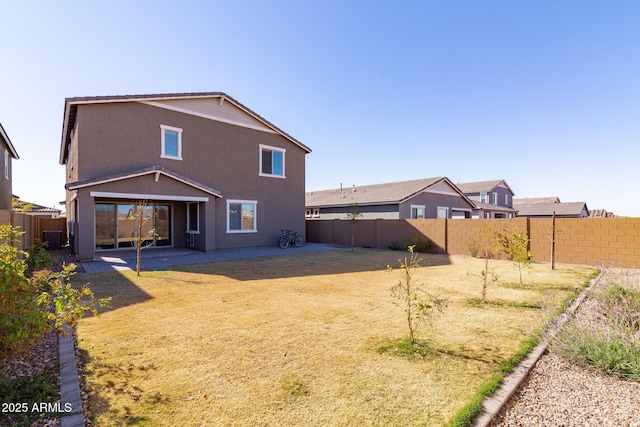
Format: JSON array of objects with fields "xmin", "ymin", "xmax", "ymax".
[{"xmin": 457, "ymin": 179, "xmax": 516, "ymax": 218}]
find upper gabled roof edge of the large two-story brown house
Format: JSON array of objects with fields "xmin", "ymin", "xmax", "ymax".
[{"xmin": 60, "ymin": 92, "xmax": 311, "ymax": 164}]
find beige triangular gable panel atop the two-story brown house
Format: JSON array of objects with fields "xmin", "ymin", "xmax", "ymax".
[{"xmin": 138, "ymin": 98, "xmax": 276, "ymax": 133}]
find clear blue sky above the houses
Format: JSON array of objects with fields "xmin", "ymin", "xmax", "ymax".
[{"xmin": 0, "ymin": 0, "xmax": 640, "ymax": 216}]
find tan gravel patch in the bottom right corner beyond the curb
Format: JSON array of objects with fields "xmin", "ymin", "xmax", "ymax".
[{"xmin": 489, "ymin": 352, "xmax": 640, "ymax": 427}]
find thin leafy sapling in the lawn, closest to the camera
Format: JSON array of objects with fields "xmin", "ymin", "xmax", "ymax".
[{"xmin": 387, "ymin": 246, "xmax": 447, "ymax": 344}]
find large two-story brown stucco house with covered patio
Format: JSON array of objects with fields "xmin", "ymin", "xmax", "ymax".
[{"xmin": 60, "ymin": 92, "xmax": 311, "ymax": 260}]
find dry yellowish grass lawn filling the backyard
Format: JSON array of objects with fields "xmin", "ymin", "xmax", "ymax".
[{"xmin": 75, "ymin": 249, "xmax": 592, "ymax": 426}]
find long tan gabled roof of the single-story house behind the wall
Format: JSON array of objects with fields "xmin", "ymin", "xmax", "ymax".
[{"xmin": 305, "ymin": 177, "xmax": 473, "ymax": 207}]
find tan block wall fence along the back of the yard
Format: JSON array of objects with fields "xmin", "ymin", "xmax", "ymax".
[{"xmin": 306, "ymin": 218, "xmax": 640, "ymax": 268}]
